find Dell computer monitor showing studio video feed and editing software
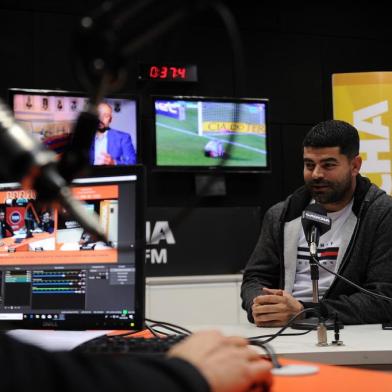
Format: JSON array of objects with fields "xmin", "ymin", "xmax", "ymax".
[{"xmin": 0, "ymin": 166, "xmax": 145, "ymax": 329}]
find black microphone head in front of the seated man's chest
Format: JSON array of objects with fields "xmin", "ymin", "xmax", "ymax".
[{"xmin": 301, "ymin": 203, "xmax": 331, "ymax": 256}]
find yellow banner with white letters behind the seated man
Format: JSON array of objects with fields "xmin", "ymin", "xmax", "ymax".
[{"xmin": 332, "ymin": 72, "xmax": 392, "ymax": 194}]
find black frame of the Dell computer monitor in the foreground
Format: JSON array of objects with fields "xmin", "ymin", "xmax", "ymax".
[{"xmin": 0, "ymin": 165, "xmax": 146, "ymax": 330}]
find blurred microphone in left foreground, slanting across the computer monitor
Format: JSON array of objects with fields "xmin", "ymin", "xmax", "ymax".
[{"xmin": 0, "ymin": 100, "xmax": 106, "ymax": 242}]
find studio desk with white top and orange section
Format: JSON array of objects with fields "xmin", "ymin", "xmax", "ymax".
[{"xmin": 9, "ymin": 324, "xmax": 392, "ymax": 392}]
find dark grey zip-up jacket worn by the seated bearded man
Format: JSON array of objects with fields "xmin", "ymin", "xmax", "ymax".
[{"xmin": 241, "ymin": 175, "xmax": 392, "ymax": 324}]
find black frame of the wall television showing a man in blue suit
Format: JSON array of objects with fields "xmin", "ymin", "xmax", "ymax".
[{"xmin": 7, "ymin": 87, "xmax": 141, "ymax": 174}]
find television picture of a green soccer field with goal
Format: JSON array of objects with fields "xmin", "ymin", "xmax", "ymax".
[{"xmin": 154, "ymin": 97, "xmax": 268, "ymax": 170}]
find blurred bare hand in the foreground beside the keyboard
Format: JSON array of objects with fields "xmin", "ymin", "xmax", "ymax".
[{"xmin": 168, "ymin": 331, "xmax": 272, "ymax": 392}]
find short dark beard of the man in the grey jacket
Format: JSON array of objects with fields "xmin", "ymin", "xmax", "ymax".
[{"xmin": 305, "ymin": 173, "xmax": 352, "ymax": 204}]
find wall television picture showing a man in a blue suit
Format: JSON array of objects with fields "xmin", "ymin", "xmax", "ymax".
[{"xmin": 9, "ymin": 89, "xmax": 138, "ymax": 166}]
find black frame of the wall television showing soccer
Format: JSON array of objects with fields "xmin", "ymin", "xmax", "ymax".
[{"xmin": 151, "ymin": 95, "xmax": 271, "ymax": 174}]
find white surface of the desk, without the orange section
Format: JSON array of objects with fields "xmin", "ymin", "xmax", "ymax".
[{"xmin": 8, "ymin": 324, "xmax": 392, "ymax": 365}]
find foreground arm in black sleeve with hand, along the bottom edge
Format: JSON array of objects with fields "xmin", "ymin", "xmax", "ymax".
[{"xmin": 0, "ymin": 332, "xmax": 271, "ymax": 392}]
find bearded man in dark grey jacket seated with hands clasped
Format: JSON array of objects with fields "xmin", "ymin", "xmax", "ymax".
[{"xmin": 241, "ymin": 120, "xmax": 392, "ymax": 326}]
